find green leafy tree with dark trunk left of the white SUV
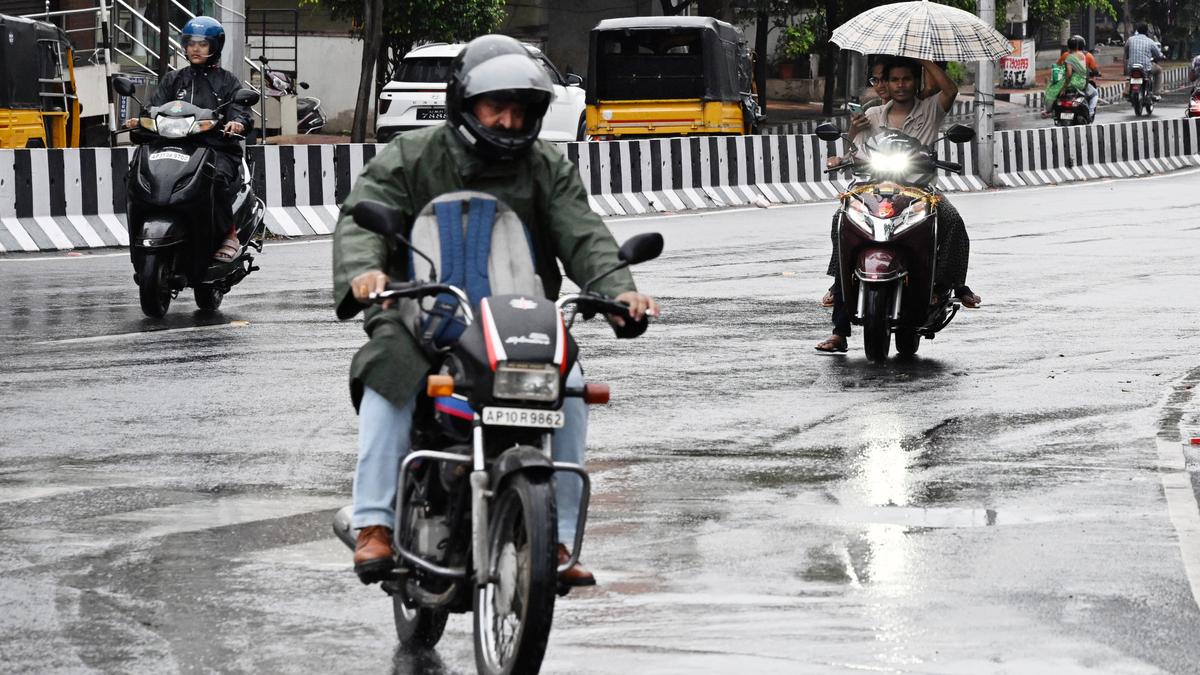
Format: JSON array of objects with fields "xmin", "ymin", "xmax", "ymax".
[{"xmin": 300, "ymin": 0, "xmax": 505, "ymax": 139}]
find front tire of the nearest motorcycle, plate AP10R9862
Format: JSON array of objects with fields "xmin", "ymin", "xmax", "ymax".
[{"xmin": 473, "ymin": 473, "xmax": 558, "ymax": 675}]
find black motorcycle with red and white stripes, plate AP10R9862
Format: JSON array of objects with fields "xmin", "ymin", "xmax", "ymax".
[{"xmin": 334, "ymin": 201, "xmax": 662, "ymax": 675}]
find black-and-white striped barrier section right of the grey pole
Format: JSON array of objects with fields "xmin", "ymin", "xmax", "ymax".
[{"xmin": 996, "ymin": 119, "xmax": 1200, "ymax": 187}]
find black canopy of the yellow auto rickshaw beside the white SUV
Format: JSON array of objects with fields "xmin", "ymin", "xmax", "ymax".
[{"xmin": 587, "ymin": 17, "xmax": 752, "ymax": 104}]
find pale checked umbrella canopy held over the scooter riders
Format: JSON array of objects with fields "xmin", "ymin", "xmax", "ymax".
[{"xmin": 829, "ymin": 0, "xmax": 1013, "ymax": 61}]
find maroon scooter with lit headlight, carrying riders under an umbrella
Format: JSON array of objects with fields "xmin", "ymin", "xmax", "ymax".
[{"xmin": 816, "ymin": 124, "xmax": 974, "ymax": 362}]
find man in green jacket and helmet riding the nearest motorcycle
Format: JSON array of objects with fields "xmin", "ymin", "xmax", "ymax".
[{"xmin": 334, "ymin": 35, "xmax": 658, "ymax": 586}]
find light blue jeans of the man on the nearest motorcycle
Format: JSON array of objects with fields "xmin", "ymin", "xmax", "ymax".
[{"xmin": 350, "ymin": 363, "xmax": 588, "ymax": 548}]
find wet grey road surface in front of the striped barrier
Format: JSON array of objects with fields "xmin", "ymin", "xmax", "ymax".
[{"xmin": 0, "ymin": 172, "xmax": 1200, "ymax": 674}]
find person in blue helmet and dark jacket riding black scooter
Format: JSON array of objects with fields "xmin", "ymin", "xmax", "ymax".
[{"xmin": 126, "ymin": 17, "xmax": 254, "ymax": 262}]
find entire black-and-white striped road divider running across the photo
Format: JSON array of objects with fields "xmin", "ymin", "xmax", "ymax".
[{"xmin": 0, "ymin": 119, "xmax": 1200, "ymax": 253}]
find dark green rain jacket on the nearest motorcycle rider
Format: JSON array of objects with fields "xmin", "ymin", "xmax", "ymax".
[{"xmin": 334, "ymin": 125, "xmax": 636, "ymax": 408}]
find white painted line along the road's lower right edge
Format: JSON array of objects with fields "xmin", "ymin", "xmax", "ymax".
[{"xmin": 1154, "ymin": 371, "xmax": 1200, "ymax": 607}]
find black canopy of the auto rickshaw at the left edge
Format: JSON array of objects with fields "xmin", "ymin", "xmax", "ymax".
[{"xmin": 0, "ymin": 14, "xmax": 71, "ymax": 110}]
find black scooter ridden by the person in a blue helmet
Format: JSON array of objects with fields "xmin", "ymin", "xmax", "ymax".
[{"xmin": 113, "ymin": 77, "xmax": 265, "ymax": 318}]
